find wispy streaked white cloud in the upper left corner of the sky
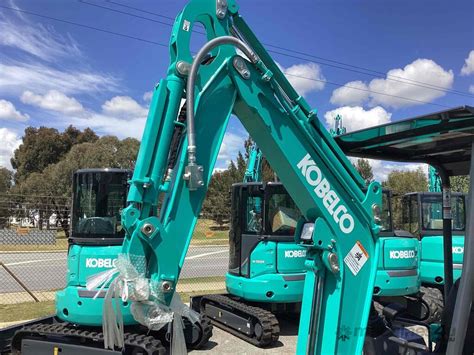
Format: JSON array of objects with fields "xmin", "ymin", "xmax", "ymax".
[{"xmin": 0, "ymin": 1, "xmax": 122, "ymax": 96}]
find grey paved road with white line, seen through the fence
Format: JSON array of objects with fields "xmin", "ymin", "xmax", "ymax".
[{"xmin": 0, "ymin": 246, "xmax": 229, "ymax": 292}]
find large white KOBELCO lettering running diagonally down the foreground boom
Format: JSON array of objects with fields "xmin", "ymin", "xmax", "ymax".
[{"xmin": 297, "ymin": 154, "xmax": 354, "ymax": 234}]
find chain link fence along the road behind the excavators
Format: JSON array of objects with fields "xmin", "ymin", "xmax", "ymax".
[{"xmin": 0, "ymin": 195, "xmax": 229, "ymax": 318}]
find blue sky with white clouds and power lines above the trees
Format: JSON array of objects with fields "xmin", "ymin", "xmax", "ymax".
[{"xmin": 0, "ymin": 0, "xmax": 474, "ymax": 179}]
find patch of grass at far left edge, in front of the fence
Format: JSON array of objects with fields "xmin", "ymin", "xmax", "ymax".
[{"xmin": 0, "ymin": 301, "xmax": 55, "ymax": 322}]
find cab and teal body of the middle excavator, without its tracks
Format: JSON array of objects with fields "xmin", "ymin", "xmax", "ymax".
[{"xmin": 226, "ymin": 182, "xmax": 306, "ymax": 303}]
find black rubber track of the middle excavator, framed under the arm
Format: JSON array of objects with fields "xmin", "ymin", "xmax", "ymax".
[{"xmin": 195, "ymin": 295, "xmax": 280, "ymax": 347}]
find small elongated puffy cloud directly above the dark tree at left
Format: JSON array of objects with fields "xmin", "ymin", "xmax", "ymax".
[{"xmin": 21, "ymin": 90, "xmax": 84, "ymax": 114}]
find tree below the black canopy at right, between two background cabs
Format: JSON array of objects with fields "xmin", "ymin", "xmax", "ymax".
[{"xmin": 382, "ymin": 168, "xmax": 428, "ymax": 227}]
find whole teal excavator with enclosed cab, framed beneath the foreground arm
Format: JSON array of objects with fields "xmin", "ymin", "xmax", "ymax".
[{"xmin": 191, "ymin": 144, "xmax": 306, "ymax": 347}]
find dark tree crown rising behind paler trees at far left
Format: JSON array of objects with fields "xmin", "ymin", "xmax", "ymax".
[{"xmin": 11, "ymin": 126, "xmax": 98, "ymax": 182}]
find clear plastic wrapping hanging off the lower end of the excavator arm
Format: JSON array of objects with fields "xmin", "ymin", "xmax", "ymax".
[{"xmin": 87, "ymin": 254, "xmax": 200, "ymax": 355}]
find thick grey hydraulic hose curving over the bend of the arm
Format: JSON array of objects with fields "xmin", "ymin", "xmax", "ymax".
[{"xmin": 186, "ymin": 36, "xmax": 258, "ymax": 165}]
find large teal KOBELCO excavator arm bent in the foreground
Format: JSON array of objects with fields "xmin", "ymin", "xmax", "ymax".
[{"xmin": 123, "ymin": 0, "xmax": 382, "ymax": 354}]
